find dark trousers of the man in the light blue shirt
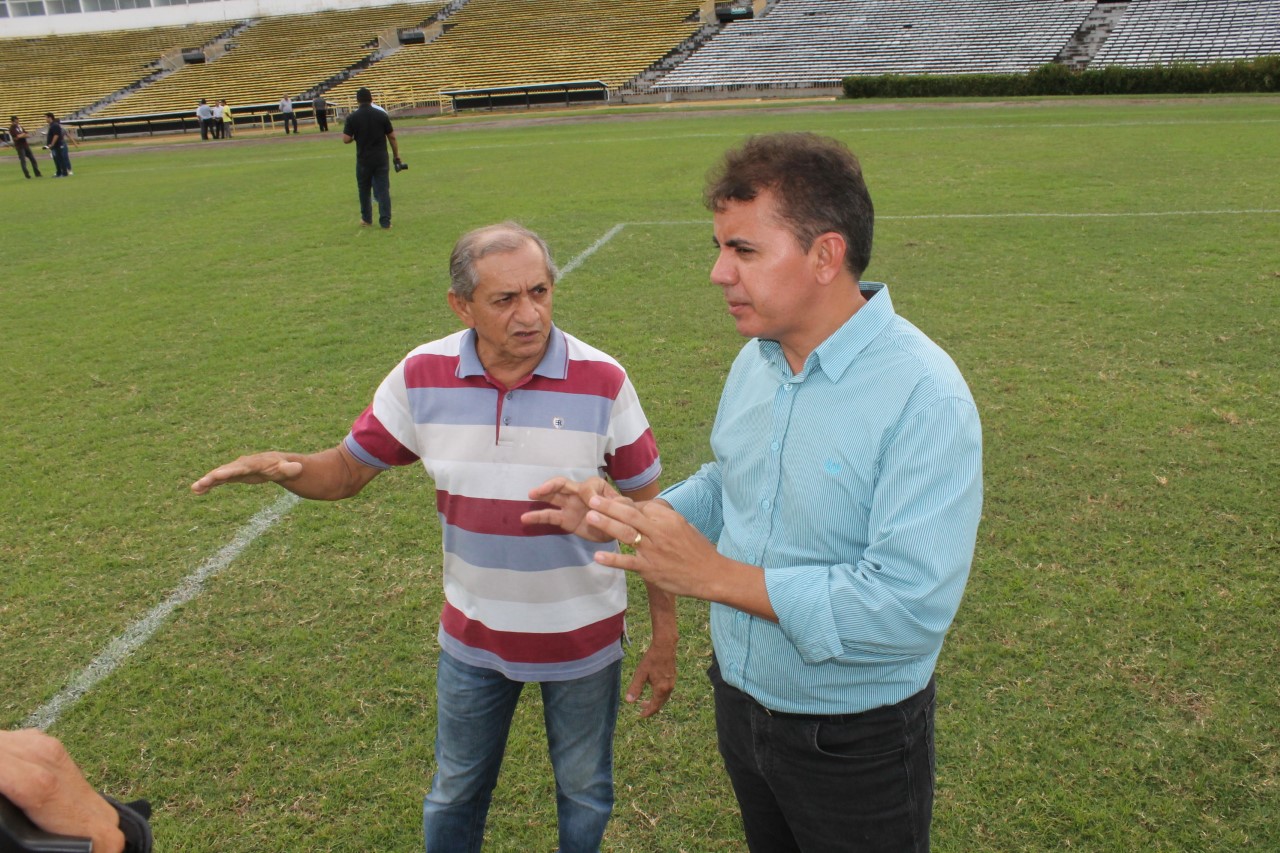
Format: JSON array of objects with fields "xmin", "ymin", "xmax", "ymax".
[{"xmin": 708, "ymin": 663, "xmax": 934, "ymax": 853}]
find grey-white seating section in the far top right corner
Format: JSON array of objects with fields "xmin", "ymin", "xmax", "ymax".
[{"xmin": 1089, "ymin": 0, "xmax": 1280, "ymax": 68}]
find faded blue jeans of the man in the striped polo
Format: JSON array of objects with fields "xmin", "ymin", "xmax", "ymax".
[{"xmin": 422, "ymin": 652, "xmax": 622, "ymax": 853}]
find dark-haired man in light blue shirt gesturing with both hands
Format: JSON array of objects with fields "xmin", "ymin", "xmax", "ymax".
[{"xmin": 525, "ymin": 133, "xmax": 982, "ymax": 853}]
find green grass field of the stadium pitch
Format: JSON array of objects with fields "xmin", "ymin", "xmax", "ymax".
[{"xmin": 0, "ymin": 97, "xmax": 1280, "ymax": 853}]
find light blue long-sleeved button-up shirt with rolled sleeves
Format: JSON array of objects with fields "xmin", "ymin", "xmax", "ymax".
[{"xmin": 660, "ymin": 282, "xmax": 982, "ymax": 713}]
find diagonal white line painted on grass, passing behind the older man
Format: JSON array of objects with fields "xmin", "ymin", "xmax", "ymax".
[{"xmin": 22, "ymin": 223, "xmax": 626, "ymax": 730}]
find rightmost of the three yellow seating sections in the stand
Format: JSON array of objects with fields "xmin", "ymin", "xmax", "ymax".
[{"xmin": 320, "ymin": 0, "xmax": 700, "ymax": 106}]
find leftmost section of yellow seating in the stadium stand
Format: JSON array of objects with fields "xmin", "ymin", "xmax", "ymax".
[{"xmin": 0, "ymin": 23, "xmax": 228, "ymax": 124}]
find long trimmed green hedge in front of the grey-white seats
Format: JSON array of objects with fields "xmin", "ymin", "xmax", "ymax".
[{"xmin": 844, "ymin": 56, "xmax": 1280, "ymax": 97}]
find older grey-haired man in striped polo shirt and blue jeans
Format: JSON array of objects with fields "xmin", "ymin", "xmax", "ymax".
[{"xmin": 192, "ymin": 223, "xmax": 676, "ymax": 853}]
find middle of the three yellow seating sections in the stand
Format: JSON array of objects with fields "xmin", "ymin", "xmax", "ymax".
[{"xmin": 95, "ymin": 3, "xmax": 443, "ymax": 118}]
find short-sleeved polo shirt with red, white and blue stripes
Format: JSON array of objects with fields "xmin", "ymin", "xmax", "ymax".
[{"xmin": 346, "ymin": 328, "xmax": 662, "ymax": 681}]
